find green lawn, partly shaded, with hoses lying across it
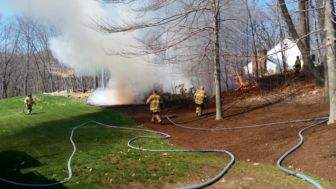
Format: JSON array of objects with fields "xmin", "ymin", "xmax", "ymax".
[{"xmin": 0, "ymin": 95, "xmax": 336, "ymax": 189}]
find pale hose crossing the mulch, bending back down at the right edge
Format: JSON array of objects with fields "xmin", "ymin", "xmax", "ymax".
[{"xmin": 167, "ymin": 117, "xmax": 329, "ymax": 189}]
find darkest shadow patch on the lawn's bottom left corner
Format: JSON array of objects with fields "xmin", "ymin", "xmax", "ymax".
[{"xmin": 0, "ymin": 150, "xmax": 67, "ymax": 189}]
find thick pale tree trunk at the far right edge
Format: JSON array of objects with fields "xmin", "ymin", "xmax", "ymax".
[{"xmin": 324, "ymin": 0, "xmax": 336, "ymax": 124}]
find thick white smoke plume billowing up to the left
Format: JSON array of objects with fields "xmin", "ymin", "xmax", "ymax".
[{"xmin": 0, "ymin": 0, "xmax": 178, "ymax": 105}]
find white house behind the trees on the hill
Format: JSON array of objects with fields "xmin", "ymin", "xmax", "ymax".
[{"xmin": 245, "ymin": 38, "xmax": 321, "ymax": 73}]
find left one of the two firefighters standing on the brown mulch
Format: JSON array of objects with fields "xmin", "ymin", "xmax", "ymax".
[{"xmin": 146, "ymin": 90, "xmax": 163, "ymax": 125}]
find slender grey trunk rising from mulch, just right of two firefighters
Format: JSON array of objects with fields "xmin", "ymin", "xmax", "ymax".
[{"xmin": 210, "ymin": 0, "xmax": 223, "ymax": 120}]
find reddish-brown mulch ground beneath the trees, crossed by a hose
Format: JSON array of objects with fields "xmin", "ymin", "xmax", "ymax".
[{"xmin": 106, "ymin": 94, "xmax": 336, "ymax": 183}]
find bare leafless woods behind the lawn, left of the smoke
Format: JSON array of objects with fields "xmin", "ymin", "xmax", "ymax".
[{"xmin": 0, "ymin": 16, "xmax": 113, "ymax": 99}]
